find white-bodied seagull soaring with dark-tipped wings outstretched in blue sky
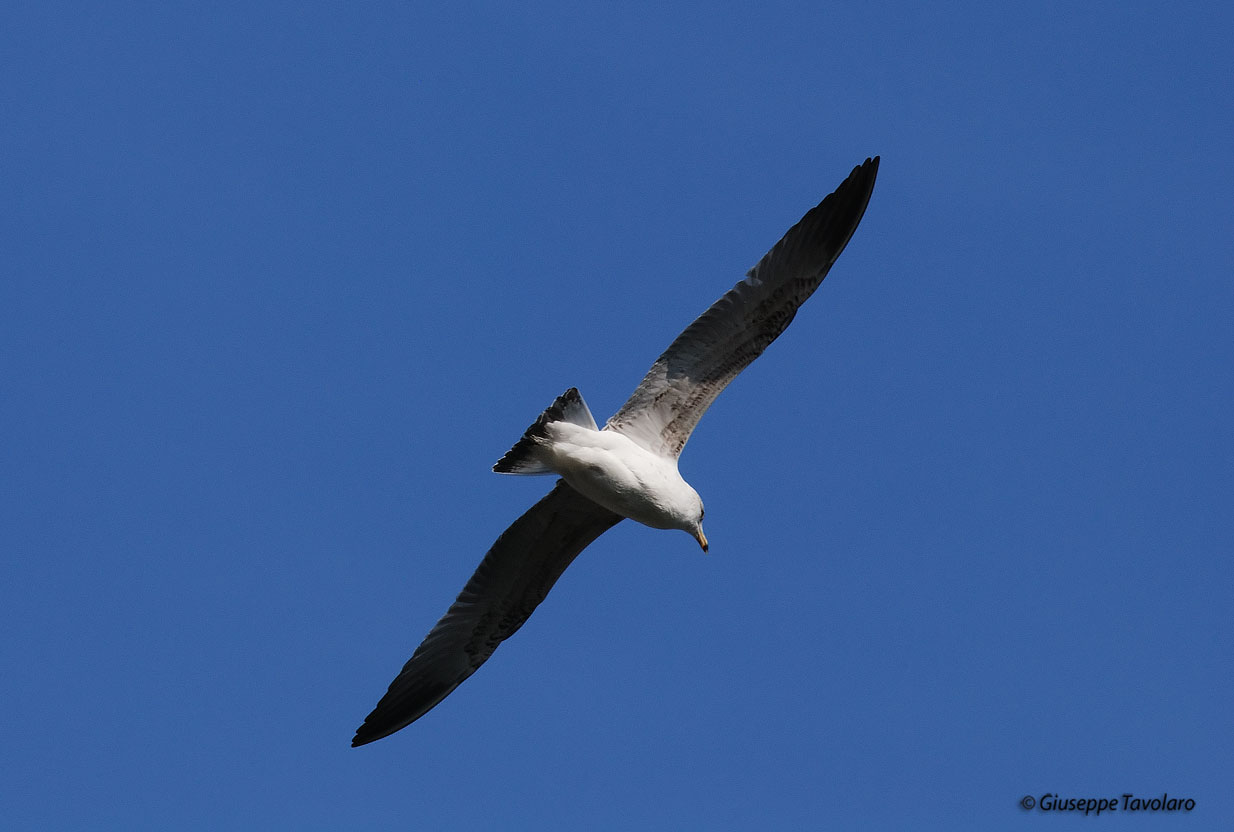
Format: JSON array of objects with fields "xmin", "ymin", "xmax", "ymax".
[{"xmin": 352, "ymin": 157, "xmax": 879, "ymax": 747}]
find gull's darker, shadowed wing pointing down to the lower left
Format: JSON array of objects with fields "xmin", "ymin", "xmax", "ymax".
[{"xmin": 352, "ymin": 480, "xmax": 622, "ymax": 746}]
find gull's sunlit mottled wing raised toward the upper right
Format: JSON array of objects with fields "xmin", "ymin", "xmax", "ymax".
[{"xmin": 607, "ymin": 157, "xmax": 879, "ymax": 457}]
